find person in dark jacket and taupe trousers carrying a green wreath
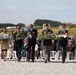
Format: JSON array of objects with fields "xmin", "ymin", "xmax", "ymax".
[{"xmin": 42, "ymin": 24, "xmax": 53, "ymax": 63}]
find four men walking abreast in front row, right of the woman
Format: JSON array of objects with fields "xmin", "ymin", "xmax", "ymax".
[{"xmin": 13, "ymin": 24, "xmax": 71, "ymax": 63}]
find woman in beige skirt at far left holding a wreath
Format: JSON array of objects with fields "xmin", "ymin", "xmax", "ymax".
[{"xmin": 0, "ymin": 28, "xmax": 9, "ymax": 61}]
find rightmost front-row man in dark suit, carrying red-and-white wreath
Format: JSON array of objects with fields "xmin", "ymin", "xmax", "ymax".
[{"xmin": 58, "ymin": 24, "xmax": 68, "ymax": 63}]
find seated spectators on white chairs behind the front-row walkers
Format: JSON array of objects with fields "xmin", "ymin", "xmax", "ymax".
[{"xmin": 0, "ymin": 39, "xmax": 76, "ymax": 61}]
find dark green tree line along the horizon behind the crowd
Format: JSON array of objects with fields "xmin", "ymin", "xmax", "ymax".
[{"xmin": 0, "ymin": 19, "xmax": 76, "ymax": 29}]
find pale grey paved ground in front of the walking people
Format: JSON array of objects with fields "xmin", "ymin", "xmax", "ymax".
[{"xmin": 0, "ymin": 59, "xmax": 76, "ymax": 75}]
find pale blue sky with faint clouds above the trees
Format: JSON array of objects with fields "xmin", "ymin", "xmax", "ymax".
[{"xmin": 0, "ymin": 0, "xmax": 76, "ymax": 25}]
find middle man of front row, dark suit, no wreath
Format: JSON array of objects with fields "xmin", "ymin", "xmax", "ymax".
[{"xmin": 27, "ymin": 24, "xmax": 38, "ymax": 62}]
